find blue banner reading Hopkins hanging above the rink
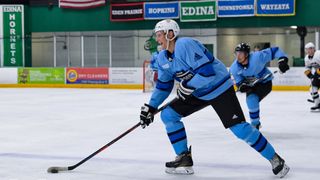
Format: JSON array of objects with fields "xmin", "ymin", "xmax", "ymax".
[{"xmin": 144, "ymin": 2, "xmax": 179, "ymax": 19}]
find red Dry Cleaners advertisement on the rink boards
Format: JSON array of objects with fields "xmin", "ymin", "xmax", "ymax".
[{"xmin": 66, "ymin": 68, "xmax": 109, "ymax": 84}]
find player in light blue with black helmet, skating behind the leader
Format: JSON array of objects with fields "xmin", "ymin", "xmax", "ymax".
[{"xmin": 230, "ymin": 43, "xmax": 289, "ymax": 129}]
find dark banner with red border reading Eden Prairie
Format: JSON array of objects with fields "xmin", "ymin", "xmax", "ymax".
[{"xmin": 110, "ymin": 3, "xmax": 144, "ymax": 21}]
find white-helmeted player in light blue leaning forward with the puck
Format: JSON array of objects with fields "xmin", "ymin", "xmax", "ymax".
[{"xmin": 140, "ymin": 19, "xmax": 289, "ymax": 177}]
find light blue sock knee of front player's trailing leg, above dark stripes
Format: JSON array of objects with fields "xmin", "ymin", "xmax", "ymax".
[{"xmin": 230, "ymin": 122, "xmax": 261, "ymax": 145}]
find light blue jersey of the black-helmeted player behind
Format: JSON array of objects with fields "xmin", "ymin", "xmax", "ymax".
[{"xmin": 230, "ymin": 47, "xmax": 287, "ymax": 86}]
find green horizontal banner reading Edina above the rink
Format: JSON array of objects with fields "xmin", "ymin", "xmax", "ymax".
[{"xmin": 180, "ymin": 0, "xmax": 217, "ymax": 22}]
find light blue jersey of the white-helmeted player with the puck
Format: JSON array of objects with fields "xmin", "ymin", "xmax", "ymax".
[{"xmin": 149, "ymin": 37, "xmax": 233, "ymax": 108}]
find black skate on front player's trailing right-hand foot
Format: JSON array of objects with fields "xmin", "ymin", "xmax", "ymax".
[{"xmin": 270, "ymin": 153, "xmax": 290, "ymax": 178}]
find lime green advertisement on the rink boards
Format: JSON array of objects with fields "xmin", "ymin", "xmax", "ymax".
[{"xmin": 18, "ymin": 68, "xmax": 65, "ymax": 84}]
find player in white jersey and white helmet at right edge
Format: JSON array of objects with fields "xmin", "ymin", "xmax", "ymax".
[{"xmin": 304, "ymin": 42, "xmax": 320, "ymax": 111}]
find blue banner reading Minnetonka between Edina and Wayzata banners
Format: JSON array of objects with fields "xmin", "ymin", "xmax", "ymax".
[{"xmin": 218, "ymin": 0, "xmax": 254, "ymax": 17}]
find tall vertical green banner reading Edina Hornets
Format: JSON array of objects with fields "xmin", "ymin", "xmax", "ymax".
[{"xmin": 0, "ymin": 5, "xmax": 24, "ymax": 67}]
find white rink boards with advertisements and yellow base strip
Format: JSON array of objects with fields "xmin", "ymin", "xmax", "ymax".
[{"xmin": 0, "ymin": 67, "xmax": 310, "ymax": 91}]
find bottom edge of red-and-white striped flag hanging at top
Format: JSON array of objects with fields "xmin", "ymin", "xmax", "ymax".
[{"xmin": 59, "ymin": 0, "xmax": 106, "ymax": 9}]
